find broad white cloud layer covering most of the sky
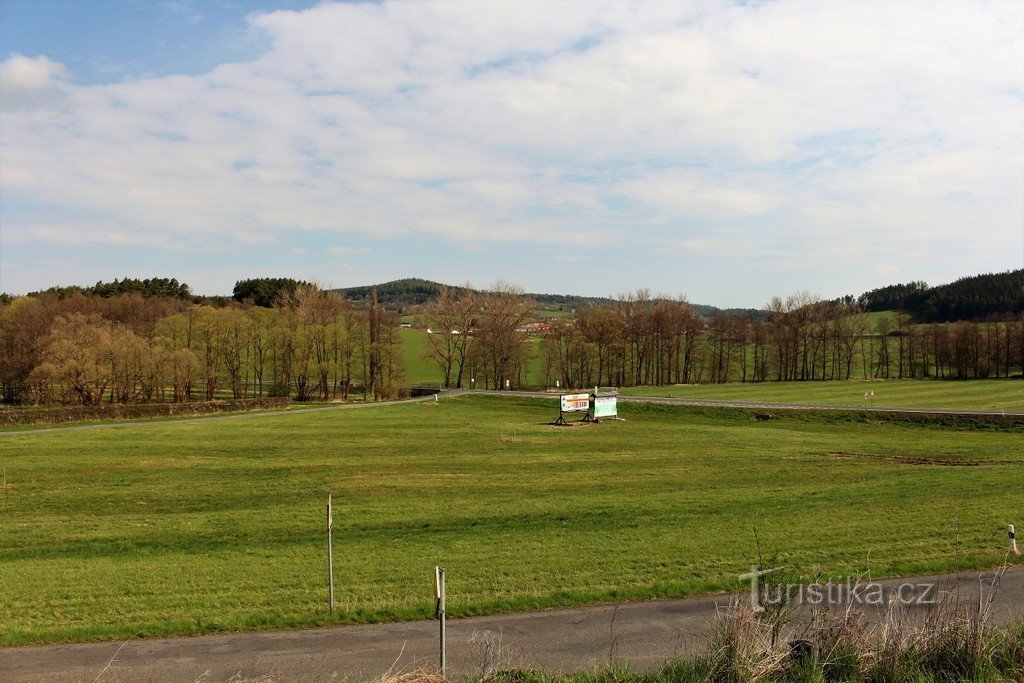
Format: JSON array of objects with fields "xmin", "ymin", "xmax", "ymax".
[{"xmin": 0, "ymin": 2, "xmax": 1024, "ymax": 296}]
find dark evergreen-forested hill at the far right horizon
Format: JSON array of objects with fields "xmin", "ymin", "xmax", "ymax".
[{"xmin": 858, "ymin": 268, "xmax": 1024, "ymax": 323}]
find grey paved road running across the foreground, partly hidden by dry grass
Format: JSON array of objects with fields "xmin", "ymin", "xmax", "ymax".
[{"xmin": 0, "ymin": 567, "xmax": 1024, "ymax": 682}]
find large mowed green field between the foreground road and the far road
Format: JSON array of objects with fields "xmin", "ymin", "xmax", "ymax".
[{"xmin": 0, "ymin": 396, "xmax": 1024, "ymax": 645}]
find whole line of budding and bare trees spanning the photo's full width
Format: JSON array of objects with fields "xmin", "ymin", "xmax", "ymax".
[{"xmin": 6, "ymin": 282, "xmax": 1024, "ymax": 404}]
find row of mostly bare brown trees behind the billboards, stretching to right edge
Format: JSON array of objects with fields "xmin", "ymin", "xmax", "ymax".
[{"xmin": 424, "ymin": 290, "xmax": 1024, "ymax": 388}]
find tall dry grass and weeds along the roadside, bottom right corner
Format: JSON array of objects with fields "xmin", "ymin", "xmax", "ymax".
[{"xmin": 708, "ymin": 568, "xmax": 1024, "ymax": 683}]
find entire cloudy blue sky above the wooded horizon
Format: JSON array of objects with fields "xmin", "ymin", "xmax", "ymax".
[{"xmin": 0, "ymin": 0, "xmax": 1024, "ymax": 307}]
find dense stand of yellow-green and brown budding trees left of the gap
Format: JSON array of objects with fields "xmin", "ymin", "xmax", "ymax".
[{"xmin": 0, "ymin": 285, "xmax": 403, "ymax": 404}]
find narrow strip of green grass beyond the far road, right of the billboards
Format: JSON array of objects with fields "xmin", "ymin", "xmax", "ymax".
[{"xmin": 622, "ymin": 380, "xmax": 1024, "ymax": 411}]
